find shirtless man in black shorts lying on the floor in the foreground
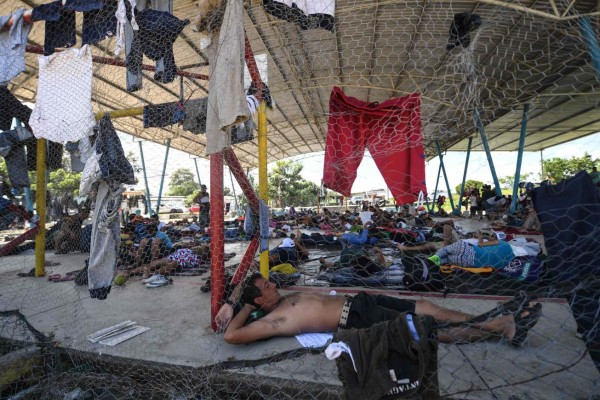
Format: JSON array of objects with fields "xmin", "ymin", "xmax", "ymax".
[{"xmin": 215, "ymin": 273, "xmax": 542, "ymax": 347}]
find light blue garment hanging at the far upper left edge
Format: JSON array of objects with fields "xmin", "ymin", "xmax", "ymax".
[{"xmin": 0, "ymin": 8, "xmax": 31, "ymax": 85}]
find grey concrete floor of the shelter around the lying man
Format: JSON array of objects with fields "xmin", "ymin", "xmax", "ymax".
[{"xmin": 0, "ymin": 220, "xmax": 600, "ymax": 399}]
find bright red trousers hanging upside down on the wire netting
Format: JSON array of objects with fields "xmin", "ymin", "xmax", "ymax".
[{"xmin": 323, "ymin": 87, "xmax": 427, "ymax": 204}]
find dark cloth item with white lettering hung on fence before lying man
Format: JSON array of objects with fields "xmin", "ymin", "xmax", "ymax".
[{"xmin": 333, "ymin": 312, "xmax": 437, "ymax": 400}]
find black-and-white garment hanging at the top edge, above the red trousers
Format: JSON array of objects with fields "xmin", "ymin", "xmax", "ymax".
[{"xmin": 263, "ymin": 0, "xmax": 335, "ymax": 32}]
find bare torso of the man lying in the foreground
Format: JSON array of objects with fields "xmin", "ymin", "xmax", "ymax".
[{"xmin": 261, "ymin": 293, "xmax": 345, "ymax": 336}]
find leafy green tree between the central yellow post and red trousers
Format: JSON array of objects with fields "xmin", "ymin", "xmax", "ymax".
[{"xmin": 269, "ymin": 160, "xmax": 319, "ymax": 207}]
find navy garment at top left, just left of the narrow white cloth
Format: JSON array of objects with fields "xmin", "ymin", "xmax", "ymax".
[{"xmin": 81, "ymin": 0, "xmax": 117, "ymax": 44}]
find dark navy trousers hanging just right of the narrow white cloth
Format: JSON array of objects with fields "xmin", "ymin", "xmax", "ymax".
[{"xmin": 126, "ymin": 3, "xmax": 185, "ymax": 91}]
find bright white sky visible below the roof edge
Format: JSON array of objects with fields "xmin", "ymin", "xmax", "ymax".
[{"xmin": 119, "ymin": 133, "xmax": 600, "ymax": 202}]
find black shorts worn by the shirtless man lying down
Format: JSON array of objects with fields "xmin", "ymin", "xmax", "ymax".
[{"xmin": 346, "ymin": 292, "xmax": 416, "ymax": 329}]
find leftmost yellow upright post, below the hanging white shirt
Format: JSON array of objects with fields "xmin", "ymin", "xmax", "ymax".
[{"xmin": 35, "ymin": 139, "xmax": 46, "ymax": 276}]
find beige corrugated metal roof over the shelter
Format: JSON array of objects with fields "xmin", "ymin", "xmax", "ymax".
[{"xmin": 0, "ymin": 0, "xmax": 600, "ymax": 167}]
